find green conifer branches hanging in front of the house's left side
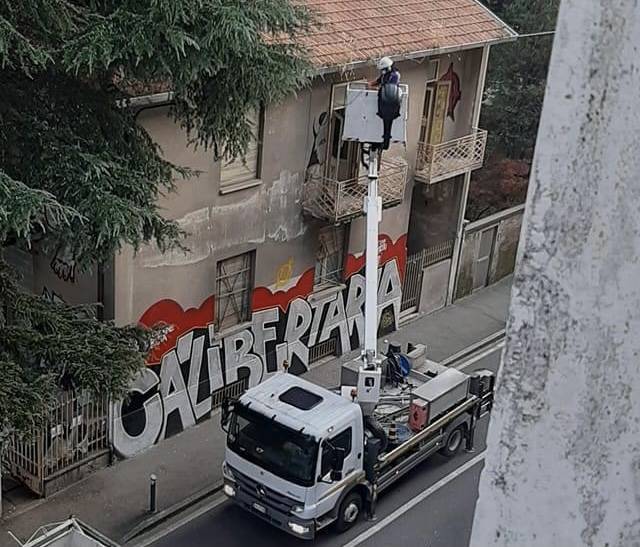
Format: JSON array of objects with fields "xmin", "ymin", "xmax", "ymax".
[{"xmin": 0, "ymin": 0, "xmax": 312, "ymax": 436}]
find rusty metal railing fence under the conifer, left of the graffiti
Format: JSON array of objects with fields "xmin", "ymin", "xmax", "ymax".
[{"xmin": 3, "ymin": 391, "xmax": 111, "ymax": 496}]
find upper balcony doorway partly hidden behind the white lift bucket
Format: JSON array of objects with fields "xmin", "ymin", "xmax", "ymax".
[{"xmin": 326, "ymin": 83, "xmax": 360, "ymax": 181}]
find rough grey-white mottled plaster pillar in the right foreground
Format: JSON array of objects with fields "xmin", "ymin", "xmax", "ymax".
[{"xmin": 471, "ymin": 0, "xmax": 640, "ymax": 547}]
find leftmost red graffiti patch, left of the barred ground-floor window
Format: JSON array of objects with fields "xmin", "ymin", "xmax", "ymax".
[{"xmin": 139, "ymin": 296, "xmax": 215, "ymax": 365}]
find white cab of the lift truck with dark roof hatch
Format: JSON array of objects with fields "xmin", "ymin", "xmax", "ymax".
[{"xmin": 223, "ymin": 373, "xmax": 365, "ymax": 539}]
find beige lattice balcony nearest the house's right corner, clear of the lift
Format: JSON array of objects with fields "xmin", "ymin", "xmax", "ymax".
[{"xmin": 416, "ymin": 129, "xmax": 487, "ymax": 184}]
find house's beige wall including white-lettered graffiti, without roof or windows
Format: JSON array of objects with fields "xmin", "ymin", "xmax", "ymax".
[{"xmin": 106, "ymin": 50, "xmax": 481, "ymax": 456}]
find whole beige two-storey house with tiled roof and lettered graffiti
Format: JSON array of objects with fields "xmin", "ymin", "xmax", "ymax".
[{"xmin": 7, "ymin": 0, "xmax": 515, "ymax": 456}]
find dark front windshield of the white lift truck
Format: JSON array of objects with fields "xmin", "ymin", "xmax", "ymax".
[{"xmin": 227, "ymin": 405, "xmax": 318, "ymax": 486}]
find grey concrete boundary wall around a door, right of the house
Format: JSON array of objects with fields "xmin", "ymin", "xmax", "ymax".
[{"xmin": 455, "ymin": 205, "xmax": 524, "ymax": 299}]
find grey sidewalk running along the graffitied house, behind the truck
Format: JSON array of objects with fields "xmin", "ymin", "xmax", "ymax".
[{"xmin": 0, "ymin": 277, "xmax": 511, "ymax": 547}]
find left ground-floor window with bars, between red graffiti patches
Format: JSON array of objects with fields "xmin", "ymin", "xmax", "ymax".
[{"xmin": 215, "ymin": 251, "xmax": 255, "ymax": 331}]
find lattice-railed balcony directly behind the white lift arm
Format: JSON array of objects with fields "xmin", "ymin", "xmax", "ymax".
[{"xmin": 302, "ymin": 157, "xmax": 407, "ymax": 224}]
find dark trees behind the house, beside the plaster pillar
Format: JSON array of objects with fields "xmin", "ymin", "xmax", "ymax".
[{"xmin": 466, "ymin": 0, "xmax": 560, "ymax": 221}]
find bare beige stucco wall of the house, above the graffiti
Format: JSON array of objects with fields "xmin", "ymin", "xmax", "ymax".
[{"xmin": 114, "ymin": 50, "xmax": 488, "ymax": 323}]
